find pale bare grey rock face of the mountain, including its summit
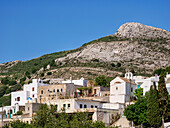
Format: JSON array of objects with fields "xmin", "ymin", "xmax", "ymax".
[{"xmin": 56, "ymin": 23, "xmax": 170, "ymax": 73}]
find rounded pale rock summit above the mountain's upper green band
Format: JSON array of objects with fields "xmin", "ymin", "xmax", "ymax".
[{"xmin": 115, "ymin": 22, "xmax": 170, "ymax": 39}]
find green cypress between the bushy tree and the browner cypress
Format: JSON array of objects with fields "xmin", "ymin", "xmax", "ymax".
[{"xmin": 147, "ymin": 84, "xmax": 161, "ymax": 127}]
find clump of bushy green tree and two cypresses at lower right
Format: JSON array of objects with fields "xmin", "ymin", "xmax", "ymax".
[{"xmin": 124, "ymin": 73, "xmax": 170, "ymax": 128}]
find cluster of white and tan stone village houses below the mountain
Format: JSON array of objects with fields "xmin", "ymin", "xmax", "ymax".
[{"xmin": 0, "ymin": 72, "xmax": 170, "ymax": 126}]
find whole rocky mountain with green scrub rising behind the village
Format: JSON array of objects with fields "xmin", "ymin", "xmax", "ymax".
[{"xmin": 0, "ymin": 23, "xmax": 170, "ymax": 82}]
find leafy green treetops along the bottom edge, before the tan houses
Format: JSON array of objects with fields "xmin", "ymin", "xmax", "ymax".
[{"xmin": 5, "ymin": 104, "xmax": 112, "ymax": 128}]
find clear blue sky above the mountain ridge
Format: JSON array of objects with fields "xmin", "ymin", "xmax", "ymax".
[{"xmin": 0, "ymin": 0, "xmax": 170, "ymax": 63}]
